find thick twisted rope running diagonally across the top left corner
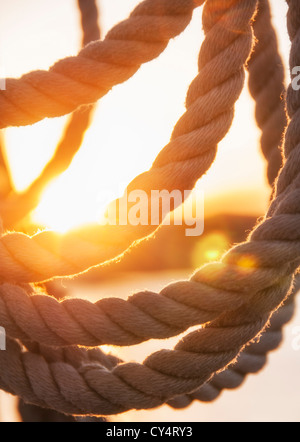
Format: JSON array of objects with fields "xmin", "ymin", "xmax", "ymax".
[{"xmin": 0, "ymin": 0, "xmax": 204, "ymax": 129}]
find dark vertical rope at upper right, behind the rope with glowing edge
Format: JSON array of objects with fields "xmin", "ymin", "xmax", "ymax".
[{"xmin": 248, "ymin": 0, "xmax": 287, "ymax": 184}]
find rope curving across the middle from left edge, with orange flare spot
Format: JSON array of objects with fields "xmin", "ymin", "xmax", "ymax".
[{"xmin": 0, "ymin": 0, "xmax": 299, "ymax": 356}]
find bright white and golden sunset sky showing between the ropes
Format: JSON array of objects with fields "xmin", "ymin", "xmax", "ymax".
[{"xmin": 0, "ymin": 0, "xmax": 290, "ymax": 230}]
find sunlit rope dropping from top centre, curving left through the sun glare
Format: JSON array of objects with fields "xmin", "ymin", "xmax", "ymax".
[{"xmin": 0, "ymin": 2, "xmax": 253, "ymax": 283}]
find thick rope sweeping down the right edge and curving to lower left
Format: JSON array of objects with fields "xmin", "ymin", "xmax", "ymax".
[{"xmin": 0, "ymin": 0, "xmax": 300, "ymax": 414}]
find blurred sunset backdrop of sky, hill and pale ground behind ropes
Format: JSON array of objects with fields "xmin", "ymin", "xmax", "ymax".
[{"xmin": 0, "ymin": 0, "xmax": 300, "ymax": 422}]
